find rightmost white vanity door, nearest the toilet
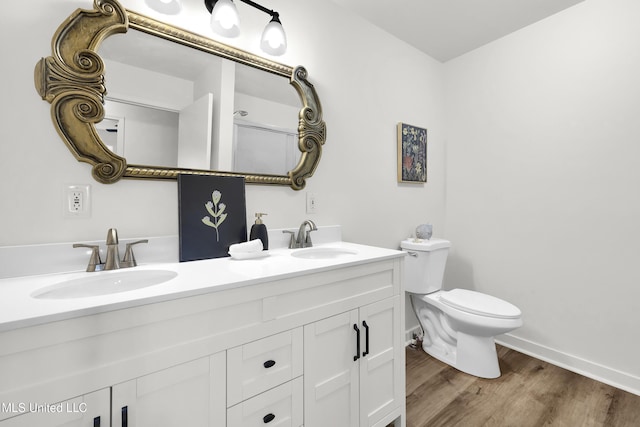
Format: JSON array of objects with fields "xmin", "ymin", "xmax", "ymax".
[{"xmin": 353, "ymin": 297, "xmax": 405, "ymax": 427}]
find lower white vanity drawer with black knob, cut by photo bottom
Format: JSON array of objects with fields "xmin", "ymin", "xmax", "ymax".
[{"xmin": 227, "ymin": 377, "xmax": 304, "ymax": 427}]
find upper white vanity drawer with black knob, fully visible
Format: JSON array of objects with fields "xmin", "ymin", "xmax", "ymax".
[{"xmin": 227, "ymin": 328, "xmax": 303, "ymax": 407}]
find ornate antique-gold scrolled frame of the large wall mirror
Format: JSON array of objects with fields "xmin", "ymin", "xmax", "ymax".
[{"xmin": 35, "ymin": 0, "xmax": 326, "ymax": 190}]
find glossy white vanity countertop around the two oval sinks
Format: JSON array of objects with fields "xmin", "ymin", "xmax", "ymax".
[{"xmin": 0, "ymin": 242, "xmax": 404, "ymax": 332}]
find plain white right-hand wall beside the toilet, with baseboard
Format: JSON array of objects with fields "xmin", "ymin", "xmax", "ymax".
[{"xmin": 445, "ymin": 0, "xmax": 640, "ymax": 393}]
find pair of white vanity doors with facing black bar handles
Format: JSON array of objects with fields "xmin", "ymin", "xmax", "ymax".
[{"xmin": 304, "ymin": 296, "xmax": 405, "ymax": 427}]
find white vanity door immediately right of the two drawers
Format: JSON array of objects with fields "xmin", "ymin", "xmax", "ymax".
[{"xmin": 304, "ymin": 310, "xmax": 359, "ymax": 427}]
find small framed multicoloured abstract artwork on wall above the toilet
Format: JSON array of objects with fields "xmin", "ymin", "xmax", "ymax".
[{"xmin": 398, "ymin": 123, "xmax": 427, "ymax": 183}]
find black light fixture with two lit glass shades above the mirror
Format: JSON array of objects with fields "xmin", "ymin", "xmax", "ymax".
[{"xmin": 204, "ymin": 0, "xmax": 287, "ymax": 55}]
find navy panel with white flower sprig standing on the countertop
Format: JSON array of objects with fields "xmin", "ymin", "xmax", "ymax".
[{"xmin": 178, "ymin": 175, "xmax": 247, "ymax": 262}]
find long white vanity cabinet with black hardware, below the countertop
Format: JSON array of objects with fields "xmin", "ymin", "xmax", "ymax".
[{"xmin": 0, "ymin": 250, "xmax": 405, "ymax": 427}]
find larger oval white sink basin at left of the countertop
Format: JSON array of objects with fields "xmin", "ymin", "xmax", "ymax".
[{"xmin": 31, "ymin": 270, "xmax": 178, "ymax": 299}]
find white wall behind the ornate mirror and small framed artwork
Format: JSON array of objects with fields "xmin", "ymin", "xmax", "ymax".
[{"xmin": 0, "ymin": 0, "xmax": 444, "ymax": 251}]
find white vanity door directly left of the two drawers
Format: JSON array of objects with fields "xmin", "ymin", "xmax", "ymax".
[{"xmin": 111, "ymin": 352, "xmax": 226, "ymax": 427}]
